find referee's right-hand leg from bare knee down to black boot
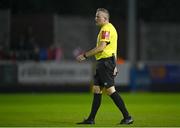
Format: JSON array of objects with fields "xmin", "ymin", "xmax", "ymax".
[{"xmin": 106, "ymin": 86, "xmax": 133, "ymax": 124}]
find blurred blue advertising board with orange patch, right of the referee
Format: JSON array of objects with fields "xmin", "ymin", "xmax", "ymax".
[{"xmin": 130, "ymin": 62, "xmax": 180, "ymax": 92}]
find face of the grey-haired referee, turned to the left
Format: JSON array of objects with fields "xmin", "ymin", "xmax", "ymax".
[{"xmin": 95, "ymin": 11, "xmax": 106, "ymax": 26}]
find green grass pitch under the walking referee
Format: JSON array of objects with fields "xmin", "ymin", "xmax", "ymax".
[{"xmin": 0, "ymin": 92, "xmax": 180, "ymax": 127}]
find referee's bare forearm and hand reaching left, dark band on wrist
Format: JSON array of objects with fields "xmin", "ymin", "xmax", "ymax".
[{"xmin": 76, "ymin": 42, "xmax": 107, "ymax": 62}]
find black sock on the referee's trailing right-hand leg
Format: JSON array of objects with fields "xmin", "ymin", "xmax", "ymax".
[{"xmin": 110, "ymin": 92, "xmax": 130, "ymax": 118}]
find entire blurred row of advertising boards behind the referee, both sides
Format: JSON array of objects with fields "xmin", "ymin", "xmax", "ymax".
[{"xmin": 0, "ymin": 61, "xmax": 180, "ymax": 93}]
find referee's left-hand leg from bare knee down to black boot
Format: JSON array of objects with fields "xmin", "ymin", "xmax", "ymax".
[{"xmin": 78, "ymin": 85, "xmax": 102, "ymax": 124}]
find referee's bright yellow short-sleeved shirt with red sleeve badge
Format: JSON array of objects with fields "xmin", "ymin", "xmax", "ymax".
[{"xmin": 95, "ymin": 23, "xmax": 118, "ymax": 60}]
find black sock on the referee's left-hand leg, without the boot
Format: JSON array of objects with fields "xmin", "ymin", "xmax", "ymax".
[{"xmin": 88, "ymin": 94, "xmax": 102, "ymax": 120}]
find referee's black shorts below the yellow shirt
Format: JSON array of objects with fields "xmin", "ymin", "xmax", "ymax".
[{"xmin": 94, "ymin": 57, "xmax": 116, "ymax": 88}]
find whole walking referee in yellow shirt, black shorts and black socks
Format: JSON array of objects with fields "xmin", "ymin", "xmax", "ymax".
[{"xmin": 76, "ymin": 8, "xmax": 133, "ymax": 124}]
